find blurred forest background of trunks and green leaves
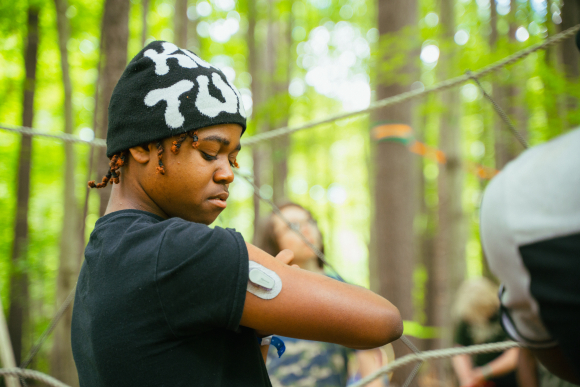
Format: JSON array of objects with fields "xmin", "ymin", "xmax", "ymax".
[{"xmin": 0, "ymin": 0, "xmax": 580, "ymax": 385}]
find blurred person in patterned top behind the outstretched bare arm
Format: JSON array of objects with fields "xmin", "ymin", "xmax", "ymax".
[{"xmin": 256, "ymin": 203, "xmax": 388, "ymax": 387}]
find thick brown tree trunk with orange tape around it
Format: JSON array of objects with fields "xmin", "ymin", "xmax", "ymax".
[{"xmin": 369, "ymin": 0, "xmax": 417, "ymax": 385}]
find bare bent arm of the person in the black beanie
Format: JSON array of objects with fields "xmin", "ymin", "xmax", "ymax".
[{"xmin": 240, "ymin": 244, "xmax": 403, "ymax": 349}]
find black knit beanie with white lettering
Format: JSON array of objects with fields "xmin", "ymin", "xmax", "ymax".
[{"xmin": 107, "ymin": 41, "xmax": 246, "ymax": 157}]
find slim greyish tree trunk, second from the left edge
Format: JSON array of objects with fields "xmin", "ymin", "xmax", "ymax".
[{"xmin": 51, "ymin": 0, "xmax": 80, "ymax": 386}]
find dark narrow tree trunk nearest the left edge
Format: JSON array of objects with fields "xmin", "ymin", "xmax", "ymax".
[{"xmin": 8, "ymin": 6, "xmax": 39, "ymax": 370}]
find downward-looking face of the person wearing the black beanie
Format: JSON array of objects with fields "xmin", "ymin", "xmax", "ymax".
[{"xmin": 139, "ymin": 124, "xmax": 242, "ymax": 224}]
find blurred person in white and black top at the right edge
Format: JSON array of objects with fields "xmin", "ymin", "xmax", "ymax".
[{"xmin": 480, "ymin": 129, "xmax": 580, "ymax": 384}]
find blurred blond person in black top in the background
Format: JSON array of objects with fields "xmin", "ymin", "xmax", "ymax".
[{"xmin": 452, "ymin": 277, "xmax": 519, "ymax": 387}]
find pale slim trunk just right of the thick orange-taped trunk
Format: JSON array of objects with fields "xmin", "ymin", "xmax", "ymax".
[{"xmin": 430, "ymin": 0, "xmax": 466, "ymax": 381}]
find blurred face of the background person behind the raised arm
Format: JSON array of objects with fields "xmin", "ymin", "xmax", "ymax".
[{"xmin": 273, "ymin": 206, "xmax": 321, "ymax": 263}]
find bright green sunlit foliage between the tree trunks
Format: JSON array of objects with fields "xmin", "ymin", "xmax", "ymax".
[{"xmin": 0, "ymin": 0, "xmax": 580, "ymax": 371}]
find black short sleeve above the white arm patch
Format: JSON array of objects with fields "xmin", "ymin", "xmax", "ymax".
[{"xmin": 155, "ymin": 219, "xmax": 248, "ymax": 336}]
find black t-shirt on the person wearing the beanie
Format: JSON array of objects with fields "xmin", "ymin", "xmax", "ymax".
[{"xmin": 72, "ymin": 210, "xmax": 271, "ymax": 387}]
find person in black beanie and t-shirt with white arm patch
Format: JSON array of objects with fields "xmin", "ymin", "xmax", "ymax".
[{"xmin": 72, "ymin": 42, "xmax": 402, "ymax": 387}]
